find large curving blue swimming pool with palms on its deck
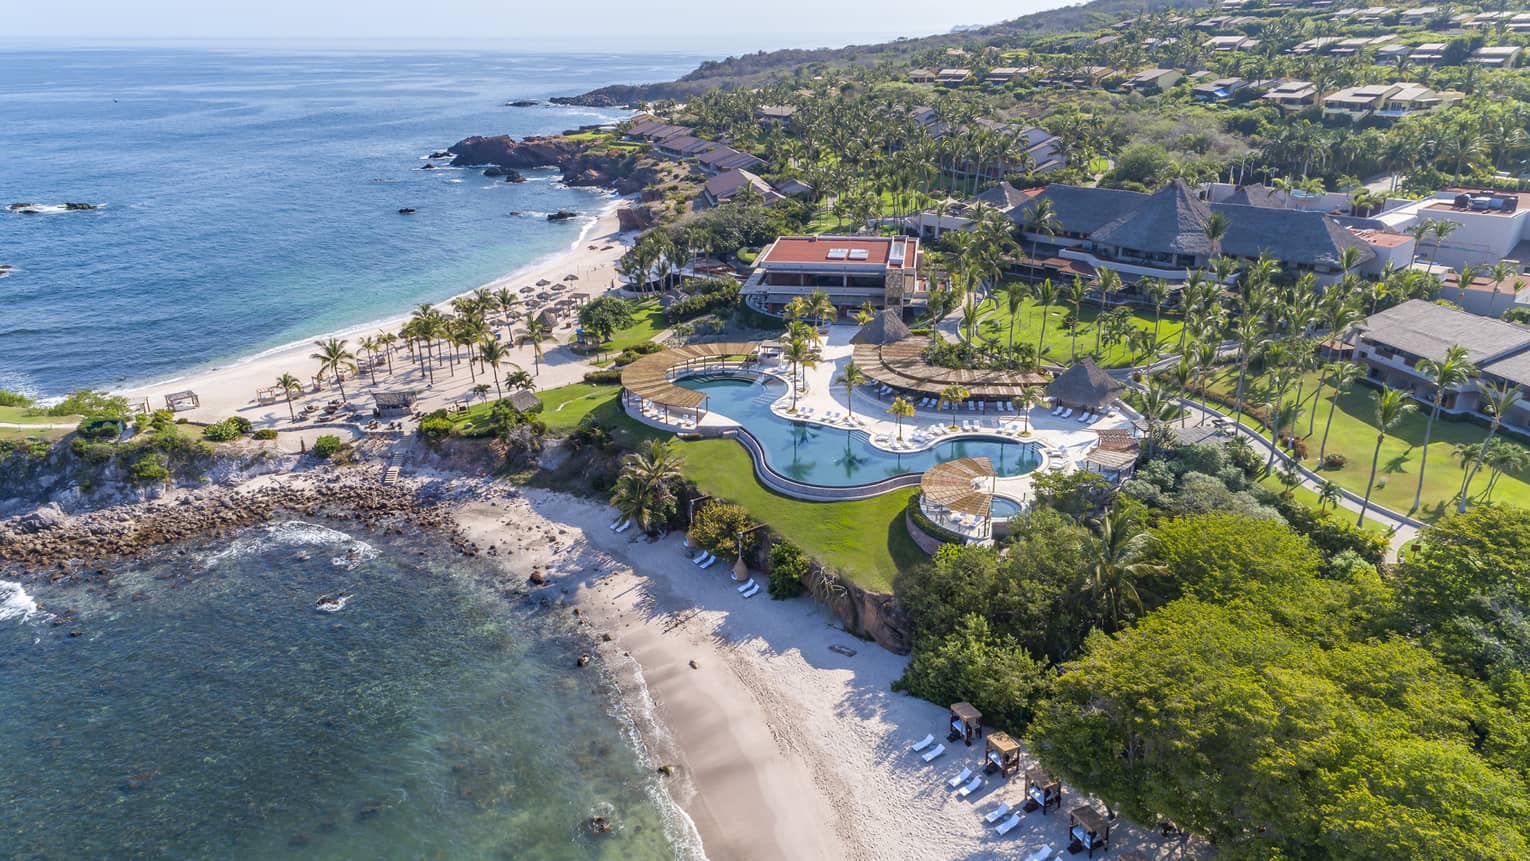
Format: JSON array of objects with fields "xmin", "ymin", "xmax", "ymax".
[{"xmin": 676, "ymin": 375, "xmax": 1040, "ymax": 488}]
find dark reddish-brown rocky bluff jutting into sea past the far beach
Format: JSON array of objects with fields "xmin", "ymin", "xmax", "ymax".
[{"xmin": 447, "ymin": 135, "xmax": 658, "ymax": 194}]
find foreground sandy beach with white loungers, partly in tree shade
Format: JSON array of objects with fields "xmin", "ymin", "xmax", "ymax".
[{"xmin": 459, "ymin": 491, "xmax": 1195, "ymax": 861}]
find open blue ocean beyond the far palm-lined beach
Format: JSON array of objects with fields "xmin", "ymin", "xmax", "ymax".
[{"xmin": 0, "ymin": 49, "xmax": 696, "ymax": 396}]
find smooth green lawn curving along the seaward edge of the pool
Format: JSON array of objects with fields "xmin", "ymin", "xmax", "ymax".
[{"xmin": 676, "ymin": 439, "xmax": 927, "ymax": 592}]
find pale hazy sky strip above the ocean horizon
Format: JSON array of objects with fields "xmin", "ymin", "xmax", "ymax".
[{"xmin": 0, "ymin": 0, "xmax": 1066, "ymax": 55}]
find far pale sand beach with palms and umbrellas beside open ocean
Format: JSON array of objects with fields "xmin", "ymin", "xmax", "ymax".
[{"xmin": 119, "ymin": 202, "xmax": 630, "ymax": 427}]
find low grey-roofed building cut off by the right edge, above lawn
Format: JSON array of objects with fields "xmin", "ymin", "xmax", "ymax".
[{"xmin": 1354, "ymin": 300, "xmax": 1530, "ymax": 433}]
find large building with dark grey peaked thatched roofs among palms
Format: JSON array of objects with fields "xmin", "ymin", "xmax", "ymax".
[{"xmin": 1010, "ymin": 180, "xmax": 1375, "ymax": 283}]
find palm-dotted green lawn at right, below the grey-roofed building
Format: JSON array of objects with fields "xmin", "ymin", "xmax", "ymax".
[{"xmin": 1212, "ymin": 369, "xmax": 1530, "ymax": 520}]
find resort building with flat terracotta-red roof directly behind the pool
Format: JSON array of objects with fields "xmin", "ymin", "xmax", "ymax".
[{"xmin": 744, "ymin": 236, "xmax": 926, "ymax": 314}]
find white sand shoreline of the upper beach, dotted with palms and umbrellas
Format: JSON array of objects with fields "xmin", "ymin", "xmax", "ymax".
[{"xmin": 110, "ymin": 191, "xmax": 632, "ymax": 427}]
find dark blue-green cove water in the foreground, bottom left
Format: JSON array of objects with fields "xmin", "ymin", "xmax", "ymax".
[{"xmin": 0, "ymin": 521, "xmax": 684, "ymax": 861}]
